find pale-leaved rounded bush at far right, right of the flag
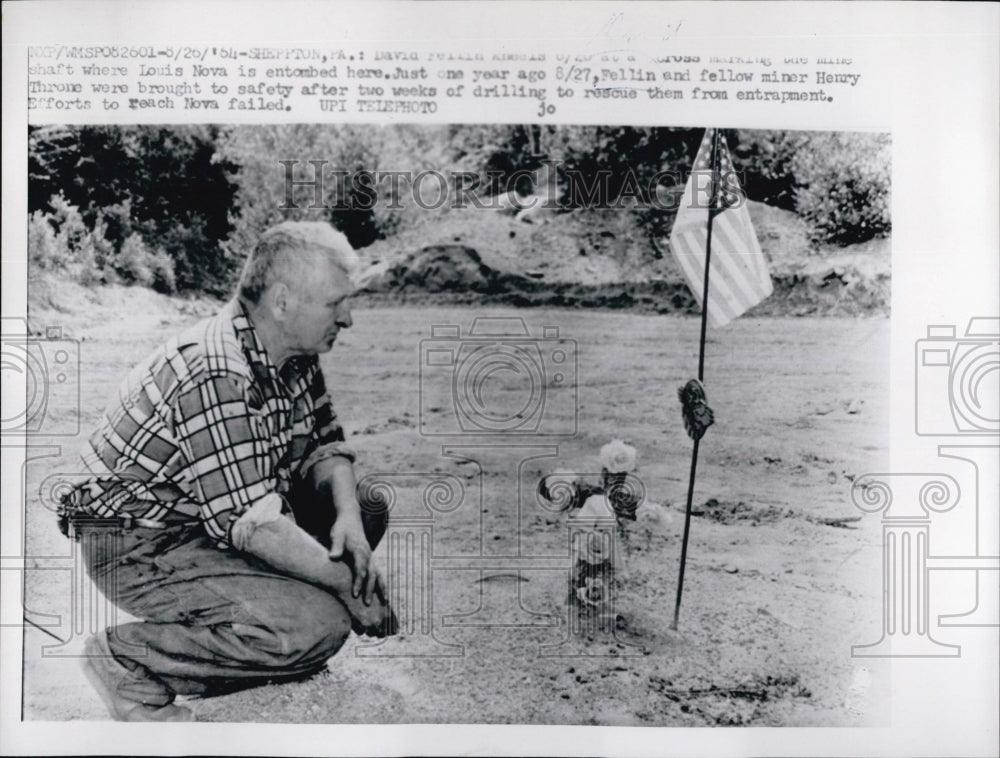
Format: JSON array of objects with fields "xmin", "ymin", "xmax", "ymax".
[{"xmin": 791, "ymin": 133, "xmax": 892, "ymax": 244}]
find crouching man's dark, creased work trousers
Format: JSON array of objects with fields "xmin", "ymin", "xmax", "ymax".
[{"xmin": 80, "ymin": 496, "xmax": 386, "ymax": 705}]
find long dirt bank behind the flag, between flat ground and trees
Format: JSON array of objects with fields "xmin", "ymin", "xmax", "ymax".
[{"xmin": 362, "ymin": 203, "xmax": 890, "ymax": 316}]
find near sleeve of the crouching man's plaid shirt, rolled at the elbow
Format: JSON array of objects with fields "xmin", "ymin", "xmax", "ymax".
[{"xmin": 173, "ymin": 375, "xmax": 275, "ymax": 548}]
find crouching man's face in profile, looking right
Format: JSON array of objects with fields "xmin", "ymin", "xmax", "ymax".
[{"xmin": 285, "ymin": 257, "xmax": 354, "ymax": 354}]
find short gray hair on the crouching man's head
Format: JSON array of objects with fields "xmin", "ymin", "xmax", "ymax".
[{"xmin": 238, "ymin": 221, "xmax": 359, "ymax": 303}]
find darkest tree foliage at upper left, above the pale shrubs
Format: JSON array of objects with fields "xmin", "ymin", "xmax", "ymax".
[{"xmin": 28, "ymin": 125, "xmax": 234, "ymax": 292}]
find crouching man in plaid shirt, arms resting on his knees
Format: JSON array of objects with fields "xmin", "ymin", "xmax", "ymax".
[{"xmin": 62, "ymin": 222, "xmax": 396, "ymax": 721}]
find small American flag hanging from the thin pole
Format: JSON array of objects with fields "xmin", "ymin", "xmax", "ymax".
[{"xmin": 670, "ymin": 129, "xmax": 773, "ymax": 327}]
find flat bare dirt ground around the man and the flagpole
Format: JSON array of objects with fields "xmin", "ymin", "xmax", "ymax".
[{"xmin": 17, "ymin": 288, "xmax": 889, "ymax": 726}]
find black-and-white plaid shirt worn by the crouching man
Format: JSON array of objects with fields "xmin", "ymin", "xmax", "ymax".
[{"xmin": 71, "ymin": 300, "xmax": 354, "ymax": 548}]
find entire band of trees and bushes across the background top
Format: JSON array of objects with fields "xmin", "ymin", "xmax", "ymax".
[{"xmin": 28, "ymin": 124, "xmax": 891, "ymax": 294}]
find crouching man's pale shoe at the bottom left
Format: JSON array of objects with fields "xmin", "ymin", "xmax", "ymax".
[{"xmin": 83, "ymin": 632, "xmax": 194, "ymax": 721}]
